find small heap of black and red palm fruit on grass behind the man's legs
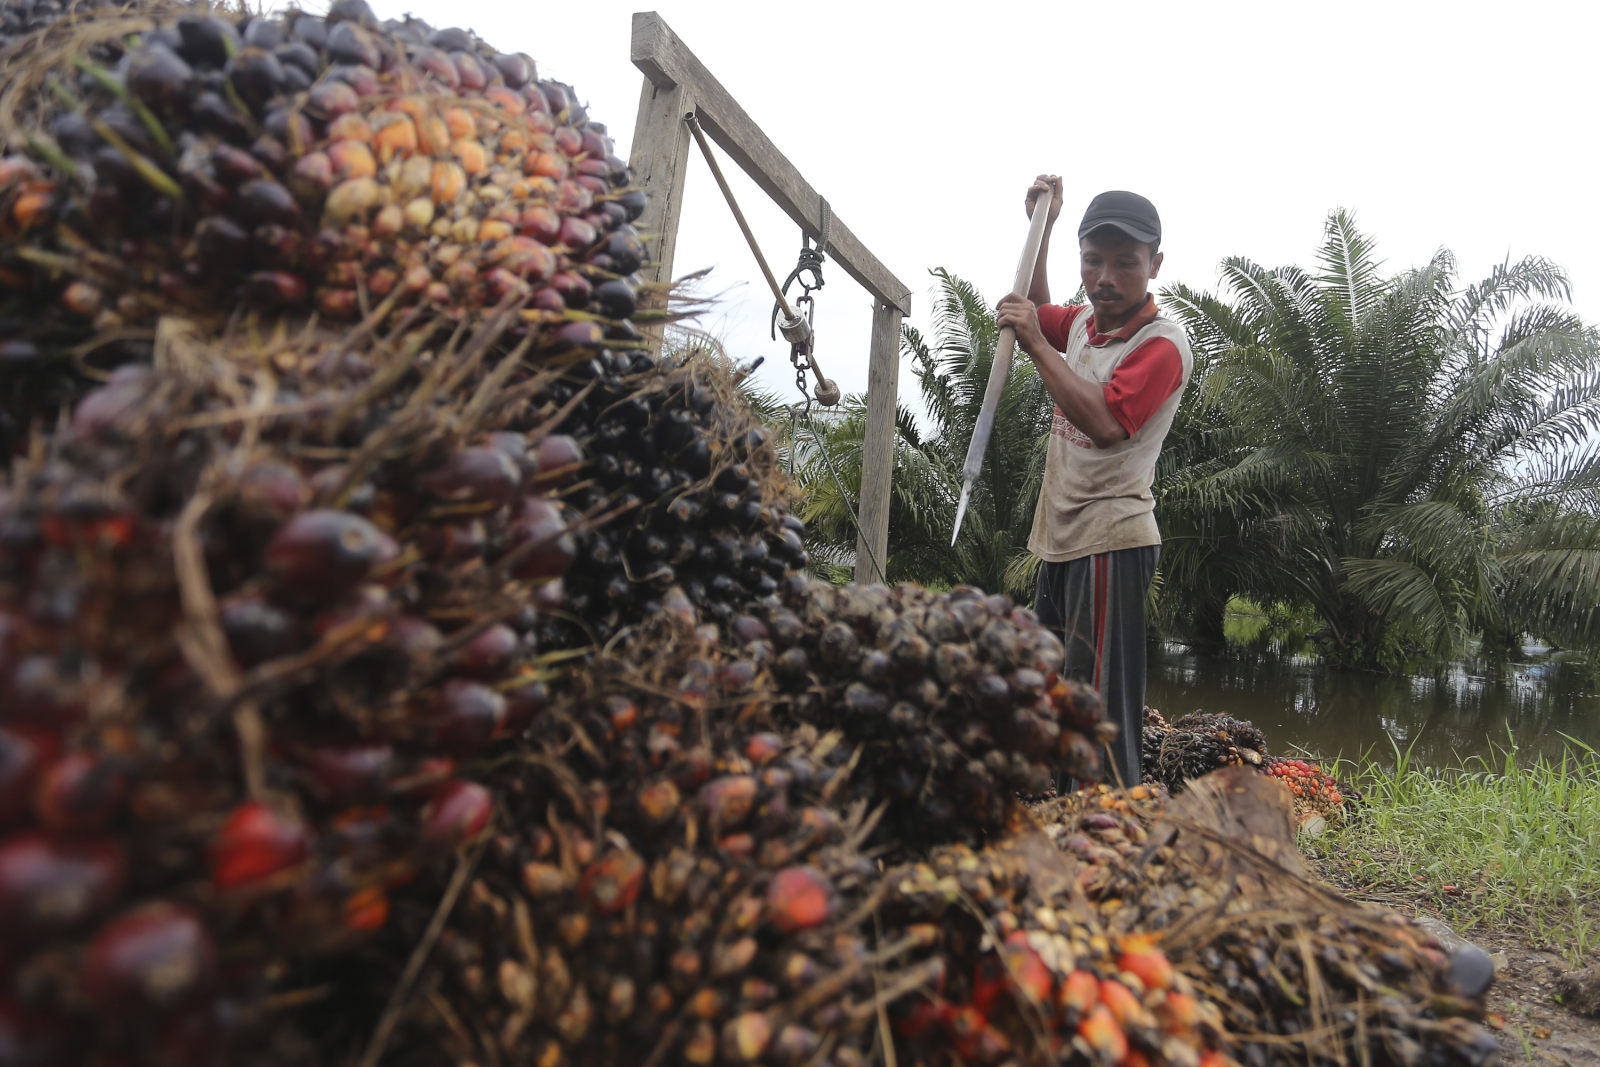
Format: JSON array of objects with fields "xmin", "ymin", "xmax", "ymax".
[{"xmin": 1139, "ymin": 707, "xmax": 1355, "ymax": 824}]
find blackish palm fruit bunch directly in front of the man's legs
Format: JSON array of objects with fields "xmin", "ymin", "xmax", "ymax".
[{"xmin": 725, "ymin": 584, "xmax": 1114, "ymax": 848}]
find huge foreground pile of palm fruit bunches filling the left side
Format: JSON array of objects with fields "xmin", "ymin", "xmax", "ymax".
[{"xmin": 0, "ymin": 0, "xmax": 1491, "ymax": 1067}]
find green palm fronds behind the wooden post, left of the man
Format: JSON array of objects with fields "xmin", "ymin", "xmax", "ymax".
[{"xmin": 797, "ymin": 269, "xmax": 1051, "ymax": 600}]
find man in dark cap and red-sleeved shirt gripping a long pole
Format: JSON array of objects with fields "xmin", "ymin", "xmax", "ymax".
[{"xmin": 998, "ymin": 174, "xmax": 1194, "ymax": 785}]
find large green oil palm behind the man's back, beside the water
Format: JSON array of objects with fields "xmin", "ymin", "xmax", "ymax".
[{"xmin": 1162, "ymin": 211, "xmax": 1600, "ymax": 665}]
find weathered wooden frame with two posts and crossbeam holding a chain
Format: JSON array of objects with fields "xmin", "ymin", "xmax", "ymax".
[{"xmin": 629, "ymin": 11, "xmax": 910, "ymax": 582}]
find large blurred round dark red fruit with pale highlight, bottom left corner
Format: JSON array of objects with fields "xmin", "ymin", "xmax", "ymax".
[{"xmin": 83, "ymin": 901, "xmax": 216, "ymax": 1016}]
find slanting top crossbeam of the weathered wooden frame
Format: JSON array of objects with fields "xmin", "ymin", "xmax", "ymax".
[{"xmin": 632, "ymin": 11, "xmax": 910, "ymax": 315}]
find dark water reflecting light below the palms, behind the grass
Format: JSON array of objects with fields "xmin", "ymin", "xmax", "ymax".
[{"xmin": 1146, "ymin": 645, "xmax": 1600, "ymax": 766}]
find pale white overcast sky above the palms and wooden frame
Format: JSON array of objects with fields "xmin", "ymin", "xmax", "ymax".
[{"xmin": 331, "ymin": 0, "xmax": 1600, "ymax": 412}]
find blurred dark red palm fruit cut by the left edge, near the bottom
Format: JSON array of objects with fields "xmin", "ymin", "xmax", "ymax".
[{"xmin": 0, "ymin": 832, "xmax": 128, "ymax": 937}]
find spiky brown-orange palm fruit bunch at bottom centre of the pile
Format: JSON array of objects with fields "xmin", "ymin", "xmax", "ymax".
[{"xmin": 336, "ymin": 614, "xmax": 942, "ymax": 1067}]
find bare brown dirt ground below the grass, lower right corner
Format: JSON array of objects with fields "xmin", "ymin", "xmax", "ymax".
[{"xmin": 1323, "ymin": 869, "xmax": 1600, "ymax": 1067}]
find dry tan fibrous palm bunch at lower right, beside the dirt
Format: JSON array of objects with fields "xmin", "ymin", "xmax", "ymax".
[{"xmin": 1035, "ymin": 768, "xmax": 1496, "ymax": 1067}]
